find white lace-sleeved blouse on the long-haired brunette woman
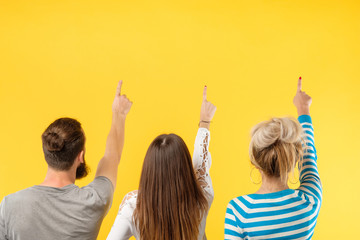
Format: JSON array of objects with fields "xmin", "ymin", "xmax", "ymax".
[{"xmin": 107, "ymin": 128, "xmax": 214, "ymax": 240}]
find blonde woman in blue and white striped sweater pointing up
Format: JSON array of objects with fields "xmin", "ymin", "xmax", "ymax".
[{"xmin": 225, "ymin": 77, "xmax": 322, "ymax": 239}]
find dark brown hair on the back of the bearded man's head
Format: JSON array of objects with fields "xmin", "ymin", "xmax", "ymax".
[{"xmin": 41, "ymin": 118, "xmax": 85, "ymax": 171}]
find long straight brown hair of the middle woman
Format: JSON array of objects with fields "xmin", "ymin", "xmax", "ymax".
[{"xmin": 133, "ymin": 134, "xmax": 208, "ymax": 240}]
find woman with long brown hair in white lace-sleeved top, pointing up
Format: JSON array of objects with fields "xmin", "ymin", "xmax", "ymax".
[{"xmin": 107, "ymin": 86, "xmax": 216, "ymax": 240}]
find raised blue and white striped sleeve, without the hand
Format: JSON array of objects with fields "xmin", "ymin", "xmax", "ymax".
[{"xmin": 298, "ymin": 115, "xmax": 322, "ymax": 202}]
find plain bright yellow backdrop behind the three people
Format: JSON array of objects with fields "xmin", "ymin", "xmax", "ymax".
[{"xmin": 0, "ymin": 0, "xmax": 360, "ymax": 240}]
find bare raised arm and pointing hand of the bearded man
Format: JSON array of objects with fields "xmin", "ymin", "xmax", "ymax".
[{"xmin": 96, "ymin": 81, "xmax": 132, "ymax": 189}]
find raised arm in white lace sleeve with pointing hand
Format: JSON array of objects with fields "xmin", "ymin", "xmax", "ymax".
[{"xmin": 193, "ymin": 86, "xmax": 216, "ymax": 196}]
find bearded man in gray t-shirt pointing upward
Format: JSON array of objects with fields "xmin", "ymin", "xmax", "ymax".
[{"xmin": 0, "ymin": 81, "xmax": 132, "ymax": 240}]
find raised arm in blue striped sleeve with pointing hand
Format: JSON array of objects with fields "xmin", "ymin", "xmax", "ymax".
[{"xmin": 294, "ymin": 78, "xmax": 322, "ymax": 201}]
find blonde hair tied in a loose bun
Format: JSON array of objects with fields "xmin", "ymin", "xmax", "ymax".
[{"xmin": 249, "ymin": 117, "xmax": 303, "ymax": 183}]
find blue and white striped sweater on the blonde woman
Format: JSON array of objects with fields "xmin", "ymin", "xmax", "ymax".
[{"xmin": 225, "ymin": 115, "xmax": 322, "ymax": 240}]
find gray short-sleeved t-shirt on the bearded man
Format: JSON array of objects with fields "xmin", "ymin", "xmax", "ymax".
[{"xmin": 0, "ymin": 176, "xmax": 114, "ymax": 240}]
